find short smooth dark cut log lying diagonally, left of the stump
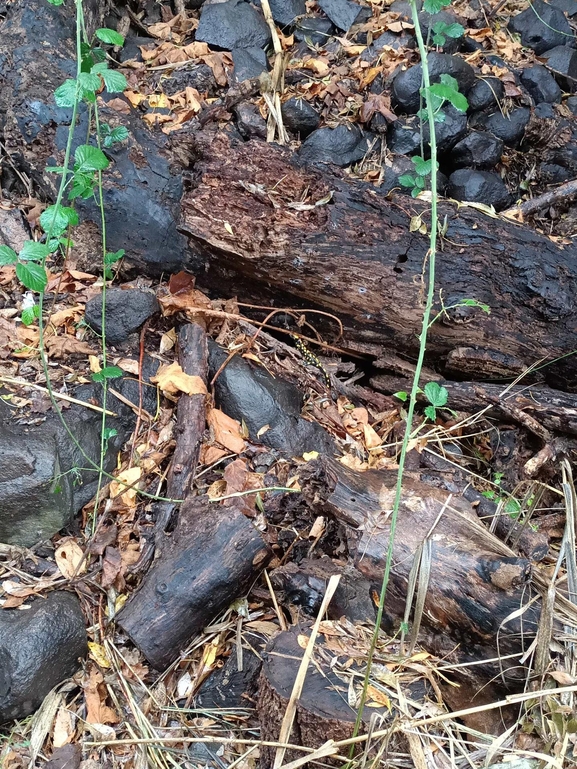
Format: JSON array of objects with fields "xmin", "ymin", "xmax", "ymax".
[{"xmin": 118, "ymin": 497, "xmax": 269, "ymax": 670}]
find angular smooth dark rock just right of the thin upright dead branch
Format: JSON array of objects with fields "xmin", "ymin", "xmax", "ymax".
[{"xmin": 209, "ymin": 339, "xmax": 334, "ymax": 457}]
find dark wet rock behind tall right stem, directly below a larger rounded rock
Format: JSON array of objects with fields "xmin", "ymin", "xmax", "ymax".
[{"xmin": 387, "ymin": 105, "xmax": 467, "ymax": 157}]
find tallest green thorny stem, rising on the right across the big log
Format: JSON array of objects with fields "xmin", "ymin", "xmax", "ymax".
[{"xmin": 350, "ymin": 0, "xmax": 437, "ymax": 758}]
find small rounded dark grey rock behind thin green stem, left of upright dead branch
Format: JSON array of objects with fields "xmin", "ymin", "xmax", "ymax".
[{"xmin": 85, "ymin": 288, "xmax": 159, "ymax": 345}]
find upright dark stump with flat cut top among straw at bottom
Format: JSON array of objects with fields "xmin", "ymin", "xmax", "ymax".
[{"xmin": 257, "ymin": 624, "xmax": 392, "ymax": 769}]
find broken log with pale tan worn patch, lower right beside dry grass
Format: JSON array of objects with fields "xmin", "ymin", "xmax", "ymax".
[{"xmin": 299, "ymin": 460, "xmax": 539, "ymax": 682}]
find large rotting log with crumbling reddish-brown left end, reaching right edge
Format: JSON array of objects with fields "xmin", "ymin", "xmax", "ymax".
[{"xmin": 181, "ymin": 135, "xmax": 577, "ymax": 389}]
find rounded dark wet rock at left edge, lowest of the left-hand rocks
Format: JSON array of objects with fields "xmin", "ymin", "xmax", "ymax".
[{"xmin": 0, "ymin": 592, "xmax": 87, "ymax": 723}]
